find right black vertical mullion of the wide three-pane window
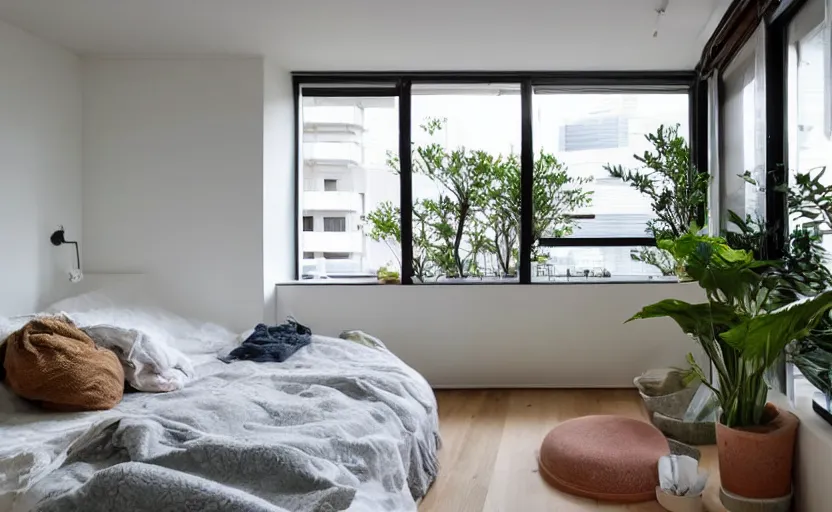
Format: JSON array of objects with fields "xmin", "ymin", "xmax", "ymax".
[{"xmin": 519, "ymin": 78, "xmax": 534, "ymax": 284}]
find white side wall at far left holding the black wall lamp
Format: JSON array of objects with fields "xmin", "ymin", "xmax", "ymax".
[{"xmin": 0, "ymin": 21, "xmax": 81, "ymax": 315}]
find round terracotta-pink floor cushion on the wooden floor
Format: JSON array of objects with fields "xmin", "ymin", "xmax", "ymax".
[{"xmin": 539, "ymin": 416, "xmax": 670, "ymax": 503}]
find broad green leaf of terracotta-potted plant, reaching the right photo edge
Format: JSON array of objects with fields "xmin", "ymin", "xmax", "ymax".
[{"xmin": 720, "ymin": 290, "xmax": 832, "ymax": 367}]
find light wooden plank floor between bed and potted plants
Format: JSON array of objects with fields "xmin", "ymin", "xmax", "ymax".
[{"xmin": 419, "ymin": 390, "xmax": 724, "ymax": 512}]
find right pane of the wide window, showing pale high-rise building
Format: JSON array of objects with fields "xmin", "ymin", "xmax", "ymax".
[{"xmin": 533, "ymin": 88, "xmax": 690, "ymax": 281}]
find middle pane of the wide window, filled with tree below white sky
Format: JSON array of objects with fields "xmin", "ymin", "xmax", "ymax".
[{"xmin": 412, "ymin": 84, "xmax": 521, "ymax": 282}]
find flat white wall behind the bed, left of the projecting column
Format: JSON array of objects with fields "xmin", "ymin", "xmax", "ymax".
[{"xmin": 83, "ymin": 58, "xmax": 264, "ymax": 330}]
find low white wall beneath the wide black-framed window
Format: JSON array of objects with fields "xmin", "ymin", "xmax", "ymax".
[{"xmin": 277, "ymin": 283, "xmax": 703, "ymax": 387}]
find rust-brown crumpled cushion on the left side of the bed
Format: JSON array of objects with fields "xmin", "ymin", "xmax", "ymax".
[{"xmin": 0, "ymin": 317, "xmax": 124, "ymax": 411}]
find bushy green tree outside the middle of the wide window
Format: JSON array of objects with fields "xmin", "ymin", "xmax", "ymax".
[{"xmin": 367, "ymin": 119, "xmax": 592, "ymax": 281}]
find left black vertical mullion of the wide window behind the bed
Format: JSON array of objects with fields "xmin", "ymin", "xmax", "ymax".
[{"xmin": 399, "ymin": 80, "xmax": 413, "ymax": 284}]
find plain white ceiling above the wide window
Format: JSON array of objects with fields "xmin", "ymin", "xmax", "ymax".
[{"xmin": 0, "ymin": 0, "xmax": 730, "ymax": 71}]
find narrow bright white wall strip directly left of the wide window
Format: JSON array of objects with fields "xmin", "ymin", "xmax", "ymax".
[{"xmin": 261, "ymin": 61, "xmax": 297, "ymax": 323}]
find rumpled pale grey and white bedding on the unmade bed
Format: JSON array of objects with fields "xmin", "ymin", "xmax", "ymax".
[{"xmin": 0, "ymin": 298, "xmax": 439, "ymax": 512}]
